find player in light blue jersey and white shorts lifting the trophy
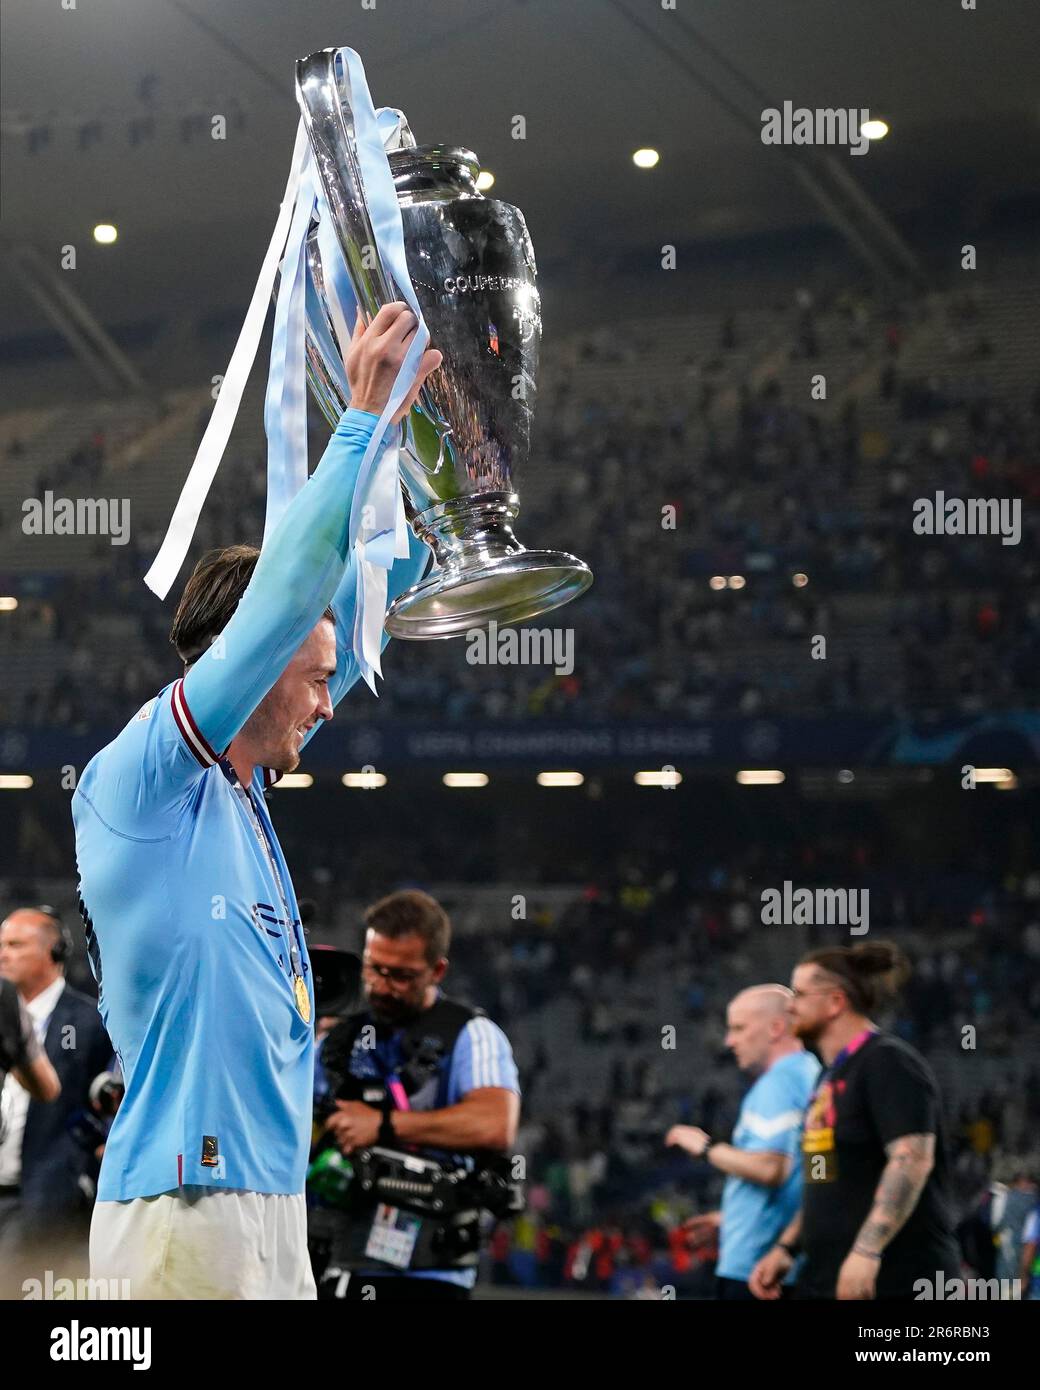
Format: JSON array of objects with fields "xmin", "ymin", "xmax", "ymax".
[{"xmin": 72, "ymin": 303, "xmax": 441, "ymax": 1298}]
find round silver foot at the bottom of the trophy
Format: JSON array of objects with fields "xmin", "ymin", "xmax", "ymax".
[{"xmin": 384, "ymin": 493, "xmax": 592, "ymax": 641}]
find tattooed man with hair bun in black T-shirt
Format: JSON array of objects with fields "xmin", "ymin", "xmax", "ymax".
[{"xmin": 749, "ymin": 941, "xmax": 959, "ymax": 1300}]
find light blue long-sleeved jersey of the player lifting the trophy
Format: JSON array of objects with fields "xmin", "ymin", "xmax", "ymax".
[{"xmin": 72, "ymin": 410, "xmax": 428, "ymax": 1201}]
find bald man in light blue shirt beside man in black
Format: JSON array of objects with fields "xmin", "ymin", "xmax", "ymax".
[{"xmin": 666, "ymin": 984, "xmax": 820, "ymax": 1300}]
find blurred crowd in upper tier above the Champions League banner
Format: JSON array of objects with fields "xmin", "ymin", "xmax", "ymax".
[{"xmin": 3, "ymin": 282, "xmax": 1040, "ymax": 730}]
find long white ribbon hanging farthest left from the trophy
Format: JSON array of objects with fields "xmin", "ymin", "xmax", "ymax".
[{"xmin": 145, "ymin": 118, "xmax": 310, "ymax": 599}]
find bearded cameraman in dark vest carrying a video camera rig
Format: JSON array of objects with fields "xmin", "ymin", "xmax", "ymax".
[{"xmin": 311, "ymin": 890, "xmax": 520, "ymax": 1301}]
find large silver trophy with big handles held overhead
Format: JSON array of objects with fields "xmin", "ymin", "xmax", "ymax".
[{"xmin": 296, "ymin": 49, "xmax": 592, "ymax": 638}]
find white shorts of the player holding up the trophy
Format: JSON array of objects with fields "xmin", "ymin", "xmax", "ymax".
[{"xmin": 90, "ymin": 1187, "xmax": 317, "ymax": 1300}]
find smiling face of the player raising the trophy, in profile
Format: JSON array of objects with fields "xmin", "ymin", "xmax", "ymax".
[{"xmin": 239, "ymin": 619, "xmax": 336, "ymax": 773}]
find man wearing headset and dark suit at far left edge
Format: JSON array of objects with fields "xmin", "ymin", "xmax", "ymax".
[{"xmin": 0, "ymin": 905, "xmax": 113, "ymax": 1273}]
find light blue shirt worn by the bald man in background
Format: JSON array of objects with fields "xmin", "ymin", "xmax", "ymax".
[{"xmin": 715, "ymin": 1052, "xmax": 820, "ymax": 1279}]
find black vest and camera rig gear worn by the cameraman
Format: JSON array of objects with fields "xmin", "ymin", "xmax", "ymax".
[{"xmin": 307, "ymin": 995, "xmax": 523, "ymax": 1273}]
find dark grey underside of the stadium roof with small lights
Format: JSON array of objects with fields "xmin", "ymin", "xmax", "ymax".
[{"xmin": 0, "ymin": 0, "xmax": 1040, "ymax": 336}]
